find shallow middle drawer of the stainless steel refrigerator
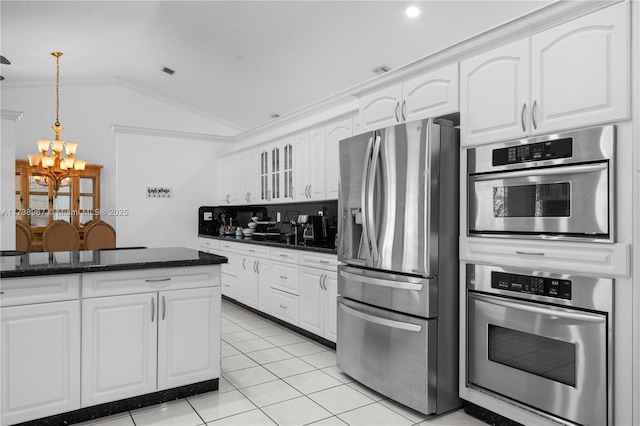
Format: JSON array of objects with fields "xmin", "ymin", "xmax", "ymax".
[{"xmin": 338, "ymin": 265, "xmax": 438, "ymax": 318}]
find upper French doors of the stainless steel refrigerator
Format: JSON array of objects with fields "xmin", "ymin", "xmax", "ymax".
[{"xmin": 338, "ymin": 120, "xmax": 440, "ymax": 276}]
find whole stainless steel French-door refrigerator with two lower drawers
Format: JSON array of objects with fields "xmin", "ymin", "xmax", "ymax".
[{"xmin": 337, "ymin": 119, "xmax": 460, "ymax": 415}]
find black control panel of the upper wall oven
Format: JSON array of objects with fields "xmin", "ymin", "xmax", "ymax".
[{"xmin": 493, "ymin": 138, "xmax": 573, "ymax": 166}]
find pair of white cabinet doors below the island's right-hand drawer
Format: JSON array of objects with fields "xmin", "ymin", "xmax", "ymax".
[{"xmin": 82, "ymin": 287, "xmax": 220, "ymax": 406}]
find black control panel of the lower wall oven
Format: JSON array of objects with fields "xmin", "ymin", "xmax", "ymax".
[{"xmin": 491, "ymin": 271, "xmax": 571, "ymax": 299}]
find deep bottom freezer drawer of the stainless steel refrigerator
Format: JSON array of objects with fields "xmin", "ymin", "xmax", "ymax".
[{"xmin": 337, "ymin": 296, "xmax": 437, "ymax": 414}]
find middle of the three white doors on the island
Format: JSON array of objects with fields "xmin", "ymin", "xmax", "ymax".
[{"xmin": 82, "ymin": 293, "xmax": 158, "ymax": 407}]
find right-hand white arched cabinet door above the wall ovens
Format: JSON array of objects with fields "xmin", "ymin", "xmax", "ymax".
[{"xmin": 531, "ymin": 2, "xmax": 630, "ymax": 133}]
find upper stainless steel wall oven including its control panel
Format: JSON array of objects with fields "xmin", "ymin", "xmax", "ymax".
[{"xmin": 467, "ymin": 125, "xmax": 615, "ymax": 242}]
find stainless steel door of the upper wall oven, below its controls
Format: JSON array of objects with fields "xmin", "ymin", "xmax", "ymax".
[{"xmin": 469, "ymin": 163, "xmax": 610, "ymax": 236}]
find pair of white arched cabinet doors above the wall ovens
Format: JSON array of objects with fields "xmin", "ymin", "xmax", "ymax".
[{"xmin": 460, "ymin": 3, "xmax": 629, "ymax": 146}]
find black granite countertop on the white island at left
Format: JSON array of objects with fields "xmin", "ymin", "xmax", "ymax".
[{"xmin": 0, "ymin": 247, "xmax": 227, "ymax": 278}]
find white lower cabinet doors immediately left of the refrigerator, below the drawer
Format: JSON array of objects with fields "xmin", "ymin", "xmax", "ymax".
[{"xmin": 299, "ymin": 266, "xmax": 338, "ymax": 342}]
